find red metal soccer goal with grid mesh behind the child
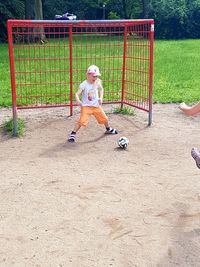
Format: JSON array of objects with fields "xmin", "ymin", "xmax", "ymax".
[{"xmin": 7, "ymin": 19, "xmax": 154, "ymax": 133}]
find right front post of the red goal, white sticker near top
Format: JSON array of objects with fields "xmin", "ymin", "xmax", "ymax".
[{"xmin": 148, "ymin": 21, "xmax": 154, "ymax": 126}]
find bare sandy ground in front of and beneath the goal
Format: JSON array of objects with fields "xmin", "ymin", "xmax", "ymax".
[{"xmin": 0, "ymin": 104, "xmax": 200, "ymax": 267}]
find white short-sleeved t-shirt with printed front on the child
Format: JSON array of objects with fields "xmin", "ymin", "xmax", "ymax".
[{"xmin": 79, "ymin": 79, "xmax": 103, "ymax": 107}]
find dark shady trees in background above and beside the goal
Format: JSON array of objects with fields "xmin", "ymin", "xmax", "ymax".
[{"xmin": 0, "ymin": 0, "xmax": 200, "ymax": 41}]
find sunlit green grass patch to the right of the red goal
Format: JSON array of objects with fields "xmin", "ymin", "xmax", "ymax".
[{"xmin": 153, "ymin": 40, "xmax": 200, "ymax": 103}]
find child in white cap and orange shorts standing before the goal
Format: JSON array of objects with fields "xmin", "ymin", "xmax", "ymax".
[{"xmin": 68, "ymin": 65, "xmax": 117, "ymax": 142}]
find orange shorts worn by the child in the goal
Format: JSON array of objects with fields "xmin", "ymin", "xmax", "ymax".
[{"xmin": 78, "ymin": 107, "xmax": 108, "ymax": 126}]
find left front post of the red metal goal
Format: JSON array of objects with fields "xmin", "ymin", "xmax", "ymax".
[{"xmin": 7, "ymin": 20, "xmax": 17, "ymax": 136}]
